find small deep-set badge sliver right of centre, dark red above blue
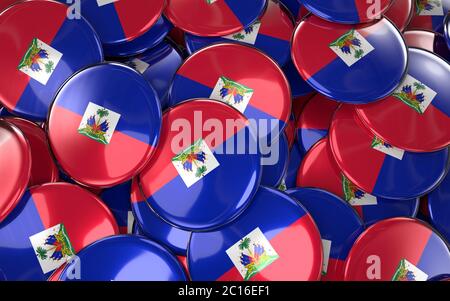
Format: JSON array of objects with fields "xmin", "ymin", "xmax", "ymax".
[{"xmin": 297, "ymin": 94, "xmax": 339, "ymax": 154}]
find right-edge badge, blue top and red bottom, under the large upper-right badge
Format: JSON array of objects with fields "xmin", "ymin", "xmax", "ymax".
[{"xmin": 356, "ymin": 48, "xmax": 450, "ymax": 152}]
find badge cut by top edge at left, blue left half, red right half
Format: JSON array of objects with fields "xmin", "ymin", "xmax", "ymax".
[{"xmin": 68, "ymin": 0, "xmax": 165, "ymax": 45}]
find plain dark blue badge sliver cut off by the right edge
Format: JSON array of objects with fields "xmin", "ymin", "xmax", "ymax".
[{"xmin": 427, "ymin": 171, "xmax": 450, "ymax": 242}]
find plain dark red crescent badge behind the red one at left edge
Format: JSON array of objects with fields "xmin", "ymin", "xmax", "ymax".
[{"xmin": 5, "ymin": 117, "xmax": 59, "ymax": 187}]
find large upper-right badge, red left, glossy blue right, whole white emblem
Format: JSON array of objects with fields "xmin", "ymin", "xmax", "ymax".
[{"xmin": 292, "ymin": 15, "xmax": 407, "ymax": 104}]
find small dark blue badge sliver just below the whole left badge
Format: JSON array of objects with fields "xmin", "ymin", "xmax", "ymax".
[{"xmin": 100, "ymin": 181, "xmax": 134, "ymax": 234}]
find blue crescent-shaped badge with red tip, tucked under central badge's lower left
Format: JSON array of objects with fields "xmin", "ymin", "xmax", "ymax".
[{"xmin": 131, "ymin": 178, "xmax": 191, "ymax": 256}]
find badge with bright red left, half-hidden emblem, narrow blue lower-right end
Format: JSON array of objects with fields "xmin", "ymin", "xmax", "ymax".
[{"xmin": 297, "ymin": 139, "xmax": 419, "ymax": 225}]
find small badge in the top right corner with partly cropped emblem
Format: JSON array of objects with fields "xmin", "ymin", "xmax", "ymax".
[{"xmin": 408, "ymin": 0, "xmax": 450, "ymax": 32}]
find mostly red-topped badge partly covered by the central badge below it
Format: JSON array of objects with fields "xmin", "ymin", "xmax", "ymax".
[{"xmin": 170, "ymin": 44, "xmax": 291, "ymax": 139}]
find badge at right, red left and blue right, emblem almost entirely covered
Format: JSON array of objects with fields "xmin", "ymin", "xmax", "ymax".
[{"xmin": 329, "ymin": 105, "xmax": 449, "ymax": 199}]
